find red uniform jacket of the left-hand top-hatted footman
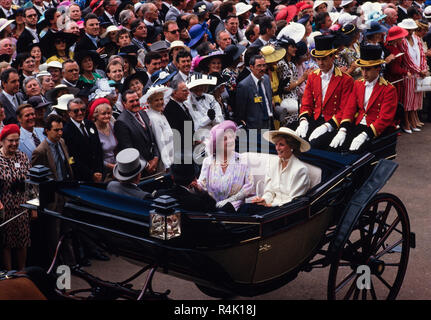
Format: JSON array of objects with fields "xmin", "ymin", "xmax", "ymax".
[{"xmin": 299, "ymin": 67, "xmax": 354, "ymax": 127}]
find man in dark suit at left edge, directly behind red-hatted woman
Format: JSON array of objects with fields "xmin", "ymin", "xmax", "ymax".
[{"xmin": 0, "ymin": 68, "xmax": 22, "ymax": 125}]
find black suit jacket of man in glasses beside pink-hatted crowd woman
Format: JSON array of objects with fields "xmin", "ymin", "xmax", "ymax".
[{"xmin": 63, "ymin": 119, "xmax": 103, "ymax": 181}]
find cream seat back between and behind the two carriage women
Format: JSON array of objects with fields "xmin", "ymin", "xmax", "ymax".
[{"xmin": 241, "ymin": 152, "xmax": 322, "ymax": 196}]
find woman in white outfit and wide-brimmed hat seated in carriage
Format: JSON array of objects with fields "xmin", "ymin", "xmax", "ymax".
[{"xmin": 249, "ymin": 127, "xmax": 310, "ymax": 213}]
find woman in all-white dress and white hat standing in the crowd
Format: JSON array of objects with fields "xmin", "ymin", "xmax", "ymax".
[{"xmin": 143, "ymin": 86, "xmax": 174, "ymax": 170}]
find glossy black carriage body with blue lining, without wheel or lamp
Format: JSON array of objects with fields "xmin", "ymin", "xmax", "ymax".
[{"xmin": 34, "ymin": 151, "xmax": 382, "ymax": 296}]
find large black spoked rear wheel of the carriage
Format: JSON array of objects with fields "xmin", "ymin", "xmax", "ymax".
[{"xmin": 328, "ymin": 193, "xmax": 410, "ymax": 300}]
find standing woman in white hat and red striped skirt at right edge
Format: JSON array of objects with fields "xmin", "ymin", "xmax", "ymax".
[{"xmin": 398, "ymin": 19, "xmax": 428, "ymax": 133}]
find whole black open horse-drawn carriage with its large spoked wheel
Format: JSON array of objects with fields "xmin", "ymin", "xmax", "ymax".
[{"xmin": 20, "ymin": 130, "xmax": 415, "ymax": 299}]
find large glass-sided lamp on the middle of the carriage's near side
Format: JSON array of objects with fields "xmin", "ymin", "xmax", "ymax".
[{"xmin": 150, "ymin": 196, "xmax": 181, "ymax": 240}]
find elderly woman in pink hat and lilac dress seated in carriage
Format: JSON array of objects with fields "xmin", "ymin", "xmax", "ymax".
[{"xmin": 198, "ymin": 120, "xmax": 254, "ymax": 213}]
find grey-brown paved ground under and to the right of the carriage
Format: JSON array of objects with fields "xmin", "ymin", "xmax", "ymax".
[{"xmin": 72, "ymin": 123, "xmax": 431, "ymax": 300}]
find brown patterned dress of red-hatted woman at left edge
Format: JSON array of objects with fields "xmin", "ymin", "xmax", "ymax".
[{"xmin": 0, "ymin": 151, "xmax": 31, "ymax": 248}]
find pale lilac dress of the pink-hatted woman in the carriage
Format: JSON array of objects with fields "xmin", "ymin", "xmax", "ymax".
[{"xmin": 198, "ymin": 152, "xmax": 254, "ymax": 210}]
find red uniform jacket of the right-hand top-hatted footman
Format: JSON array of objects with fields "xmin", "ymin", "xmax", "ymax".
[{"xmin": 341, "ymin": 77, "xmax": 398, "ymax": 137}]
